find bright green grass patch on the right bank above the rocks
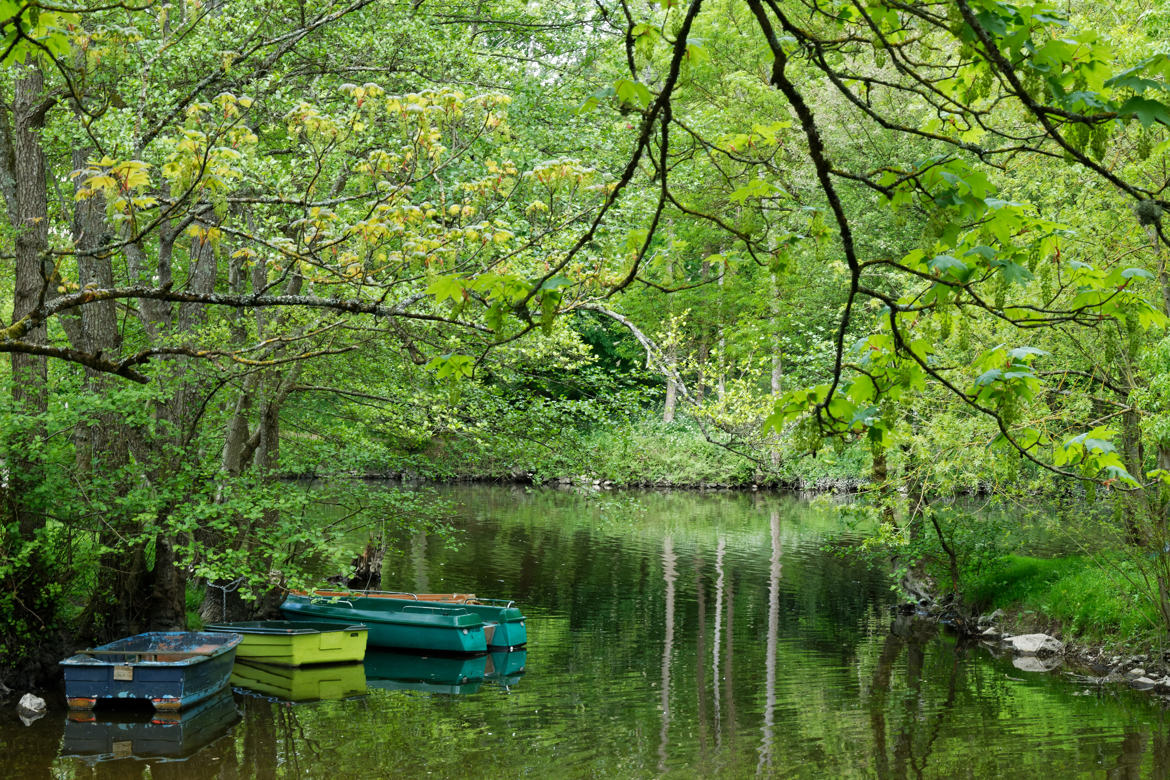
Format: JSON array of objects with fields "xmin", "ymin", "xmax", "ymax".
[{"xmin": 964, "ymin": 555, "xmax": 1159, "ymax": 644}]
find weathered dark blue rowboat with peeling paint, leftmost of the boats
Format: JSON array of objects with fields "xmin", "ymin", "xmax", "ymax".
[{"xmin": 61, "ymin": 631, "xmax": 241, "ymax": 711}]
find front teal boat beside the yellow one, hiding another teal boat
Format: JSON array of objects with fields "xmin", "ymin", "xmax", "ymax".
[{"xmin": 281, "ymin": 591, "xmax": 488, "ymax": 654}]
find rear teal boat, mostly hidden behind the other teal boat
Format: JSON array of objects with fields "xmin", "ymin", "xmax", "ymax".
[{"xmin": 282, "ymin": 591, "xmax": 528, "ymax": 651}]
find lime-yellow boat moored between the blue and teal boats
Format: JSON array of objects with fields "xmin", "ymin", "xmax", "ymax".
[{"xmin": 207, "ymin": 620, "xmax": 370, "ymax": 667}]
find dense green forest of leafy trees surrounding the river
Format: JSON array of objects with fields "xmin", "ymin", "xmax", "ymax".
[{"xmin": 0, "ymin": 0, "xmax": 1170, "ymax": 683}]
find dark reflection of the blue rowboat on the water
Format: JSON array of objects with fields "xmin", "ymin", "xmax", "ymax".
[{"xmin": 61, "ymin": 688, "xmax": 240, "ymax": 764}]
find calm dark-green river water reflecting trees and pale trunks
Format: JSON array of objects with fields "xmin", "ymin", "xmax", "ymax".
[{"xmin": 0, "ymin": 486, "xmax": 1170, "ymax": 780}]
